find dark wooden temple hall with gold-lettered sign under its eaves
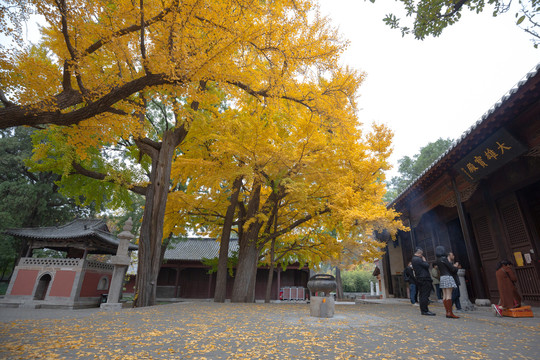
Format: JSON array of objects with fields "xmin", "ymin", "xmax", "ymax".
[{"xmin": 383, "ymin": 64, "xmax": 540, "ymax": 306}]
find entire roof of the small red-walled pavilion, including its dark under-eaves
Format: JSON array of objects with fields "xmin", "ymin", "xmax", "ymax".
[{"xmin": 4, "ymin": 219, "xmax": 138, "ymax": 254}]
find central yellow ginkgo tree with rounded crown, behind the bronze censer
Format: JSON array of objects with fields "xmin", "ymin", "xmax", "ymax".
[{"xmin": 165, "ymin": 86, "xmax": 402, "ymax": 302}]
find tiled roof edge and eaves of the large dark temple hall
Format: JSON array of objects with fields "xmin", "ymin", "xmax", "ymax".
[{"xmin": 387, "ymin": 63, "xmax": 540, "ymax": 208}]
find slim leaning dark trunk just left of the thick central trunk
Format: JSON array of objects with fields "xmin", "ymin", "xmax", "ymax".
[{"xmin": 214, "ymin": 177, "xmax": 242, "ymax": 302}]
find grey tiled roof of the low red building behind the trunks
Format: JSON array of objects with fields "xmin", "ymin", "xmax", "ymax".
[{"xmin": 164, "ymin": 237, "xmax": 238, "ymax": 261}]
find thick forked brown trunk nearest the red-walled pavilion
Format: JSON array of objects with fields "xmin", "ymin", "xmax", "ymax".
[{"xmin": 133, "ymin": 127, "xmax": 187, "ymax": 307}]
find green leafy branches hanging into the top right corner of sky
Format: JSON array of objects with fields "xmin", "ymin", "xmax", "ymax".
[{"xmin": 376, "ymin": 0, "xmax": 540, "ymax": 48}]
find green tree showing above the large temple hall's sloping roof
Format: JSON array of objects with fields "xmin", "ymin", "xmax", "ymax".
[{"xmin": 385, "ymin": 138, "xmax": 453, "ymax": 202}]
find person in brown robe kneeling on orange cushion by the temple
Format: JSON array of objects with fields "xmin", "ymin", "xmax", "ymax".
[{"xmin": 492, "ymin": 259, "xmax": 521, "ymax": 316}]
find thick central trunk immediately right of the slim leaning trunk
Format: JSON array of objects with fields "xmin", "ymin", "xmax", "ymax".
[{"xmin": 231, "ymin": 180, "xmax": 262, "ymax": 302}]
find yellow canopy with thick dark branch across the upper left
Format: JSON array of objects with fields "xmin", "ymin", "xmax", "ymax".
[{"xmin": 0, "ymin": 0, "xmax": 345, "ymax": 133}]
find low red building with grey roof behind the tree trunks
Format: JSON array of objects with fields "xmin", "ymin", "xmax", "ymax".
[{"xmin": 139, "ymin": 237, "xmax": 310, "ymax": 300}]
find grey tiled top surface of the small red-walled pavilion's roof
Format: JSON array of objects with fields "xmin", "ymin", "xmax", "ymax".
[{"xmin": 5, "ymin": 219, "xmax": 138, "ymax": 250}]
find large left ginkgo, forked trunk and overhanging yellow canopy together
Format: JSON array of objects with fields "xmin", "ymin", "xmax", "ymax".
[{"xmin": 0, "ymin": 0, "xmax": 384, "ymax": 306}]
